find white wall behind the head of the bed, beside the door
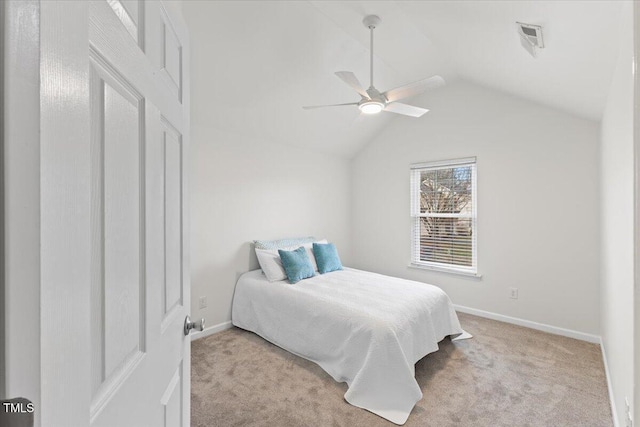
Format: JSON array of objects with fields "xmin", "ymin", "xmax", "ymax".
[{"xmin": 190, "ymin": 122, "xmax": 350, "ymax": 326}]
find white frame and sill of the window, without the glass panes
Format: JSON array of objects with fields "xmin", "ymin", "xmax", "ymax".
[{"xmin": 409, "ymin": 157, "xmax": 480, "ymax": 277}]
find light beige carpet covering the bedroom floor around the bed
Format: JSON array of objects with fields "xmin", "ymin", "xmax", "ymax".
[{"xmin": 191, "ymin": 313, "xmax": 613, "ymax": 427}]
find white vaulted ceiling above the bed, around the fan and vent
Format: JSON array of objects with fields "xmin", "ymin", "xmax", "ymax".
[{"xmin": 183, "ymin": 0, "xmax": 621, "ymax": 158}]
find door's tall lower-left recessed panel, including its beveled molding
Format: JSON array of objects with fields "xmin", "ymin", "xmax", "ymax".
[{"xmin": 90, "ymin": 54, "xmax": 146, "ymax": 416}]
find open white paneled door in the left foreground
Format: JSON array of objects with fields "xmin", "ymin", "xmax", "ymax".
[{"xmin": 39, "ymin": 0, "xmax": 190, "ymax": 427}]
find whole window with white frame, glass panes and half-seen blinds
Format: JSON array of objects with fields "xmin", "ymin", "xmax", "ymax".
[{"xmin": 411, "ymin": 157, "xmax": 477, "ymax": 274}]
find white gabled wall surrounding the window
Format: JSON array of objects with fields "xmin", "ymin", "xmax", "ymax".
[{"xmin": 352, "ymin": 81, "xmax": 599, "ymax": 335}]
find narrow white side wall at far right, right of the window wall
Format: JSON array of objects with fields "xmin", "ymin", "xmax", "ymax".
[{"xmin": 600, "ymin": 3, "xmax": 637, "ymax": 426}]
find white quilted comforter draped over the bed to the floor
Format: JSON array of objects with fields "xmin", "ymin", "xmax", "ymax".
[{"xmin": 232, "ymin": 268, "xmax": 463, "ymax": 424}]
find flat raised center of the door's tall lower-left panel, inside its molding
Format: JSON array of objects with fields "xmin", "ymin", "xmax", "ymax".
[{"xmin": 102, "ymin": 68, "xmax": 145, "ymax": 378}]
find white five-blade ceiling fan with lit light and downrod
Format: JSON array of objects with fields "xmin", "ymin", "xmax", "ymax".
[{"xmin": 302, "ymin": 15, "xmax": 445, "ymax": 117}]
